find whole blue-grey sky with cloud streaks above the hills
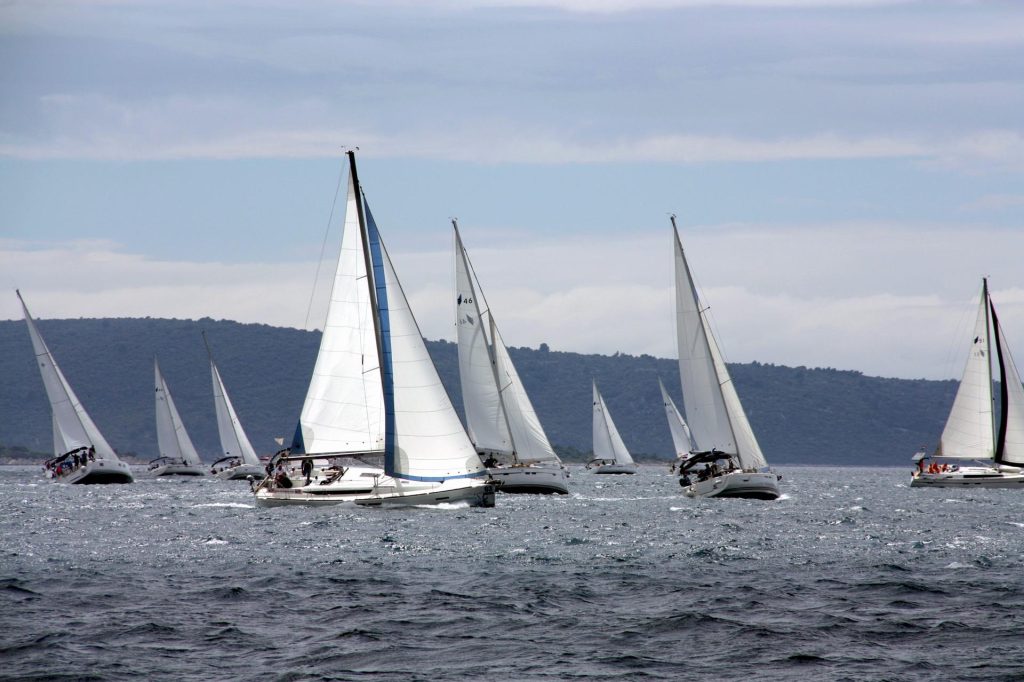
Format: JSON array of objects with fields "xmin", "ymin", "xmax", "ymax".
[{"xmin": 0, "ymin": 0, "xmax": 1024, "ymax": 379}]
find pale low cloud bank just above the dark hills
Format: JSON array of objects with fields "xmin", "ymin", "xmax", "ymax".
[{"xmin": 0, "ymin": 223, "xmax": 1024, "ymax": 378}]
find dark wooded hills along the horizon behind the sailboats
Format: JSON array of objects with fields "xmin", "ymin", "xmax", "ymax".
[{"xmin": 0, "ymin": 317, "xmax": 956, "ymax": 466}]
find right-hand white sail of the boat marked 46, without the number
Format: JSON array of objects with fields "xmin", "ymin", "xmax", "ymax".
[{"xmin": 490, "ymin": 323, "xmax": 561, "ymax": 463}]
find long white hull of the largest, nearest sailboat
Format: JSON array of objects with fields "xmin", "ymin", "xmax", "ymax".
[{"xmin": 256, "ymin": 478, "xmax": 495, "ymax": 507}]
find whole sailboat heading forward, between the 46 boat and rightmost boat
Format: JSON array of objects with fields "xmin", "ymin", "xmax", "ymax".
[{"xmin": 672, "ymin": 216, "xmax": 779, "ymax": 500}]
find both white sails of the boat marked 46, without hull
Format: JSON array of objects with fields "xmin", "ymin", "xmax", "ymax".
[{"xmin": 453, "ymin": 221, "xmax": 560, "ymax": 462}]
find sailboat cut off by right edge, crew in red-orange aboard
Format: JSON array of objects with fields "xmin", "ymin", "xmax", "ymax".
[{"xmin": 910, "ymin": 279, "xmax": 1024, "ymax": 487}]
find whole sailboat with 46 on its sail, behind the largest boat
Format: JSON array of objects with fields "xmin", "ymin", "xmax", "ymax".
[{"xmin": 452, "ymin": 220, "xmax": 568, "ymax": 495}]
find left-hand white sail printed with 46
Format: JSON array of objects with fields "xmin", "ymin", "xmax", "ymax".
[{"xmin": 455, "ymin": 229, "xmax": 514, "ymax": 455}]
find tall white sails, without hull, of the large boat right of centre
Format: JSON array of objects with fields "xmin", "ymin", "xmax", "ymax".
[{"xmin": 673, "ymin": 222, "xmax": 767, "ymax": 469}]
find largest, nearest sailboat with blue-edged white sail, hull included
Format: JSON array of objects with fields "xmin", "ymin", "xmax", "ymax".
[{"xmin": 255, "ymin": 152, "xmax": 495, "ymax": 507}]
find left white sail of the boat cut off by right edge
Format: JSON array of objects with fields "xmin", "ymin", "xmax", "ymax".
[{"xmin": 935, "ymin": 287, "xmax": 995, "ymax": 460}]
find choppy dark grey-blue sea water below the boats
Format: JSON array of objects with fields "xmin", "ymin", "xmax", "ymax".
[{"xmin": 0, "ymin": 467, "xmax": 1024, "ymax": 680}]
